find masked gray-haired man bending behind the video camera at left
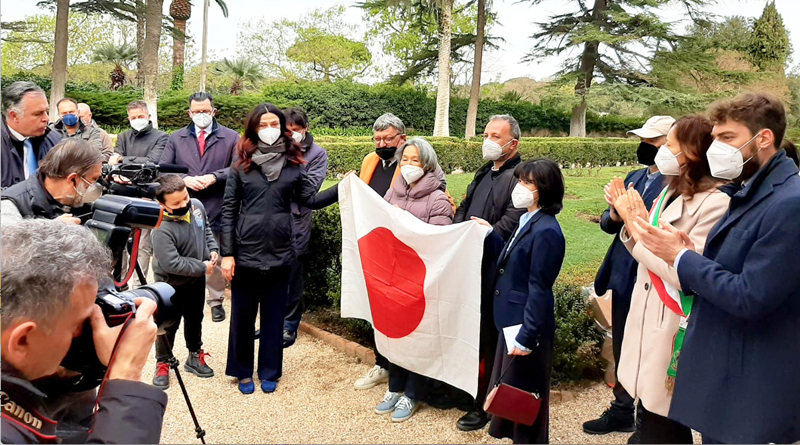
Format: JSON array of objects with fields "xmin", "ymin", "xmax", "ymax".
[{"xmin": 0, "ymin": 139, "xmax": 105, "ymax": 225}]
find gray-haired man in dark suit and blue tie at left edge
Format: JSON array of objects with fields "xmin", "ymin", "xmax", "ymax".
[{"xmin": 0, "ymin": 82, "xmax": 61, "ymax": 188}]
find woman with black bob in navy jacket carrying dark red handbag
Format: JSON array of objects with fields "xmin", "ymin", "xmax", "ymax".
[{"xmin": 472, "ymin": 158, "xmax": 565, "ymax": 443}]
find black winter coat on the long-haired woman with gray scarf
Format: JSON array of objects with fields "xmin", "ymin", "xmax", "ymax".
[{"xmin": 220, "ymin": 155, "xmax": 339, "ymax": 270}]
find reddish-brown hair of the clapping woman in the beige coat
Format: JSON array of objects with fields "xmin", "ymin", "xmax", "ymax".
[{"xmin": 667, "ymin": 116, "xmax": 717, "ymax": 198}]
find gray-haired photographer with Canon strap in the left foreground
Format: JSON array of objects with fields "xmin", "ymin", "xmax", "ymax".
[{"xmin": 0, "ymin": 219, "xmax": 167, "ymax": 443}]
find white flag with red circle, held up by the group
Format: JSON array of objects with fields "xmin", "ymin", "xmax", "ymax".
[{"xmin": 339, "ymin": 175, "xmax": 489, "ymax": 397}]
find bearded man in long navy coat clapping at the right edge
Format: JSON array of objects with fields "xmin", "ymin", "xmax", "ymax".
[{"xmin": 637, "ymin": 93, "xmax": 800, "ymax": 443}]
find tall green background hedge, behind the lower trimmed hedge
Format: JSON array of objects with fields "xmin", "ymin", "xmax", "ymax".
[{"xmin": 0, "ymin": 74, "xmax": 644, "ymax": 136}]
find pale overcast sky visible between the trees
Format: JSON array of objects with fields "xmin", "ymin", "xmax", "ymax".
[{"xmin": 0, "ymin": 0, "xmax": 800, "ymax": 82}]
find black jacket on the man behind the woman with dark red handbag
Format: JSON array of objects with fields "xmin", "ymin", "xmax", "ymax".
[{"xmin": 453, "ymin": 153, "xmax": 527, "ymax": 241}]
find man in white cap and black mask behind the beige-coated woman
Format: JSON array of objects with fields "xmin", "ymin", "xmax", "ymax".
[{"xmin": 583, "ymin": 116, "xmax": 675, "ymax": 443}]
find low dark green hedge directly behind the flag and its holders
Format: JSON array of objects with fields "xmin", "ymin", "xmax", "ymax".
[{"xmin": 303, "ymin": 204, "xmax": 602, "ymax": 382}]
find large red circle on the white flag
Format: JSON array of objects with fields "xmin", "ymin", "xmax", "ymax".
[{"xmin": 358, "ymin": 227, "xmax": 425, "ymax": 338}]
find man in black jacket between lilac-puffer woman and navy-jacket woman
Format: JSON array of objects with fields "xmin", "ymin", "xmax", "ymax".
[{"xmin": 450, "ymin": 114, "xmax": 525, "ymax": 431}]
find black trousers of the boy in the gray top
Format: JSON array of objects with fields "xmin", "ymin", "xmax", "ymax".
[{"xmin": 156, "ymin": 277, "xmax": 206, "ymax": 362}]
